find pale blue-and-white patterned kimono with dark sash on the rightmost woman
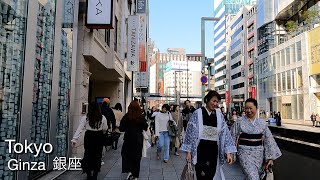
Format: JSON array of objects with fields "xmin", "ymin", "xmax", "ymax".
[{"xmin": 231, "ymin": 116, "xmax": 281, "ymax": 180}]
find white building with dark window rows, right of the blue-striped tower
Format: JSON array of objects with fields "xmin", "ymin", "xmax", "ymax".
[{"xmin": 229, "ymin": 5, "xmax": 255, "ymax": 112}]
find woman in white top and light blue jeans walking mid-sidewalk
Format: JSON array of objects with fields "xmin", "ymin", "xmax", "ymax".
[{"xmin": 152, "ymin": 104, "xmax": 173, "ymax": 163}]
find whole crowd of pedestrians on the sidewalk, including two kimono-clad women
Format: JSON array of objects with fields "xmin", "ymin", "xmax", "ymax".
[{"xmin": 72, "ymin": 91, "xmax": 281, "ymax": 180}]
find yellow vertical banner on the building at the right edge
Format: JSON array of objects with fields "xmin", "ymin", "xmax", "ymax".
[{"xmin": 308, "ymin": 27, "xmax": 320, "ymax": 75}]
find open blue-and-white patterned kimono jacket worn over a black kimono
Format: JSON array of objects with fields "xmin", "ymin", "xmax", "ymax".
[{"xmin": 181, "ymin": 108, "xmax": 237, "ymax": 180}]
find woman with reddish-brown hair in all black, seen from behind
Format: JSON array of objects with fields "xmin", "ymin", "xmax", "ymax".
[{"xmin": 119, "ymin": 101, "xmax": 148, "ymax": 179}]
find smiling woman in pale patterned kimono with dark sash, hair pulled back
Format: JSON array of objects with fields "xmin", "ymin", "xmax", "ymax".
[{"xmin": 231, "ymin": 98, "xmax": 281, "ymax": 180}]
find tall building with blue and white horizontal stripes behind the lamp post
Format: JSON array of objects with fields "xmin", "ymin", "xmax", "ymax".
[{"xmin": 214, "ymin": 0, "xmax": 256, "ymax": 106}]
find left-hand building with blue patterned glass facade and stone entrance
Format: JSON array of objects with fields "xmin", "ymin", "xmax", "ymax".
[{"xmin": 0, "ymin": 0, "xmax": 135, "ymax": 179}]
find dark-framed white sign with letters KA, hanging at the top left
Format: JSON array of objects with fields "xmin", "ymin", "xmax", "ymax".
[{"xmin": 86, "ymin": 0, "xmax": 113, "ymax": 27}]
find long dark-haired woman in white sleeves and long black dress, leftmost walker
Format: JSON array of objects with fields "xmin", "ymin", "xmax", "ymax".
[{"xmin": 71, "ymin": 103, "xmax": 108, "ymax": 180}]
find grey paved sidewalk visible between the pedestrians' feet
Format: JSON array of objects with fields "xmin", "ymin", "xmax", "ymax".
[{"xmin": 55, "ymin": 136, "xmax": 244, "ymax": 180}]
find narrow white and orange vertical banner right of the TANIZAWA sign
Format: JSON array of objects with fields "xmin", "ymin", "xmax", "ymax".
[{"xmin": 139, "ymin": 15, "xmax": 147, "ymax": 62}]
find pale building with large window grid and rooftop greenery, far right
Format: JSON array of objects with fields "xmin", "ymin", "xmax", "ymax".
[{"xmin": 257, "ymin": 0, "xmax": 320, "ymax": 123}]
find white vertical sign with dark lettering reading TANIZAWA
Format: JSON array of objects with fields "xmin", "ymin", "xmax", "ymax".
[{"xmin": 127, "ymin": 16, "xmax": 139, "ymax": 71}]
